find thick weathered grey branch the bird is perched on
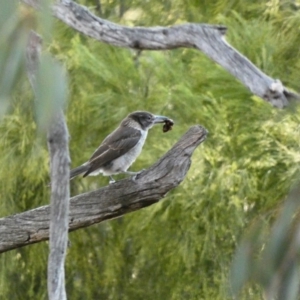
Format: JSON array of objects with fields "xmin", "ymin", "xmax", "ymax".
[{"xmin": 0, "ymin": 126, "xmax": 207, "ymax": 253}]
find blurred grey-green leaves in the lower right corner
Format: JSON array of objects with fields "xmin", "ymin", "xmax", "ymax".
[{"xmin": 231, "ymin": 187, "xmax": 300, "ymax": 300}]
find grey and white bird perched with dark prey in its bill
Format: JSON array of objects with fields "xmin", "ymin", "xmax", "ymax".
[{"xmin": 70, "ymin": 111, "xmax": 173, "ymax": 183}]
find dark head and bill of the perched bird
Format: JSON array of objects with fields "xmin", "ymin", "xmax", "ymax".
[{"xmin": 127, "ymin": 111, "xmax": 172, "ymax": 130}]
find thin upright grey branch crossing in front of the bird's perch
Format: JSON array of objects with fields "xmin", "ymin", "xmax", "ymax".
[{"xmin": 27, "ymin": 32, "xmax": 70, "ymax": 300}]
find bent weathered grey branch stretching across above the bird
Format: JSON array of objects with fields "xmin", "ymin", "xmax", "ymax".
[{"xmin": 22, "ymin": 0, "xmax": 299, "ymax": 108}]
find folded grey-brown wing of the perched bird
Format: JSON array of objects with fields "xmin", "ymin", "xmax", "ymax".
[{"xmin": 84, "ymin": 127, "xmax": 141, "ymax": 177}]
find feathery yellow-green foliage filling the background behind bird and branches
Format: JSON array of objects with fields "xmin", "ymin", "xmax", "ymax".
[{"xmin": 0, "ymin": 0, "xmax": 300, "ymax": 300}]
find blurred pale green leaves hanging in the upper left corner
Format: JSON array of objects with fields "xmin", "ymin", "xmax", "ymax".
[{"xmin": 0, "ymin": 0, "xmax": 67, "ymax": 131}]
